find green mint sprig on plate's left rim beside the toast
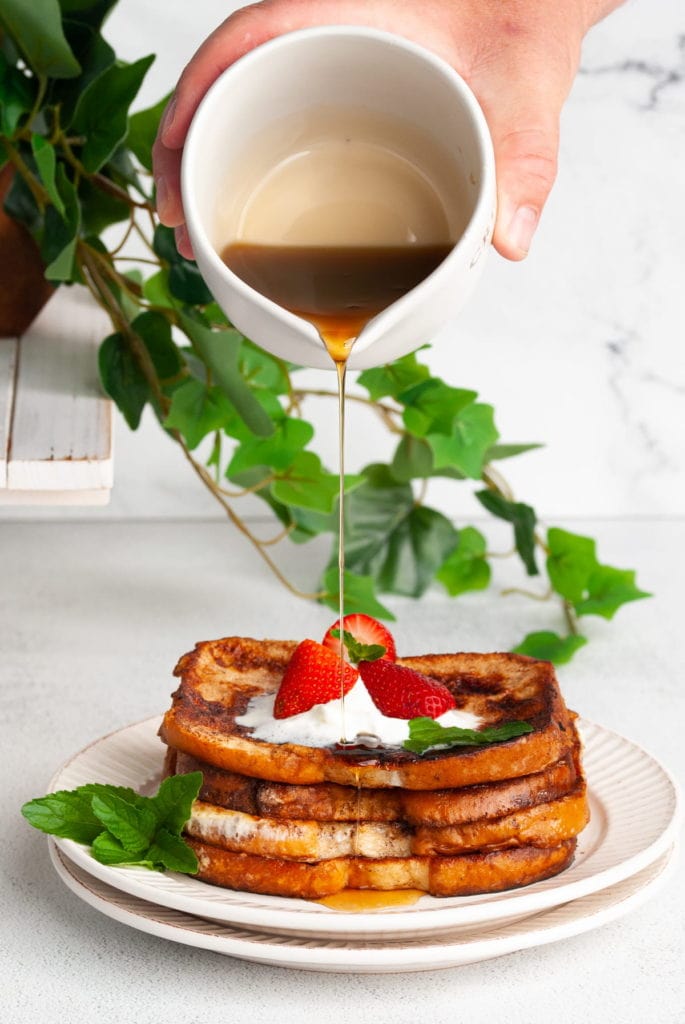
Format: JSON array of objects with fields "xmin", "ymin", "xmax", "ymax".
[{"xmin": 22, "ymin": 771, "xmax": 203, "ymax": 874}]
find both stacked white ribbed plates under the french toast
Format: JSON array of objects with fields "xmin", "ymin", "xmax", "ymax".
[{"xmin": 50, "ymin": 719, "xmax": 678, "ymax": 973}]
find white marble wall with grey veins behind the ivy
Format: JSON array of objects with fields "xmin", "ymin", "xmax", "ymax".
[{"xmin": 4, "ymin": 0, "xmax": 685, "ymax": 519}]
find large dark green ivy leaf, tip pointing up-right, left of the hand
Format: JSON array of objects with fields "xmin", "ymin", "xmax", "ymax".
[{"xmin": 72, "ymin": 54, "xmax": 155, "ymax": 173}]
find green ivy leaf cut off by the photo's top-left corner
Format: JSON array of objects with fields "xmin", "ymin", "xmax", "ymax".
[{"xmin": 0, "ymin": 0, "xmax": 81, "ymax": 79}]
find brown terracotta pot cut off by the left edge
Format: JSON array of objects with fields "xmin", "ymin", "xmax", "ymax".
[{"xmin": 0, "ymin": 165, "xmax": 54, "ymax": 338}]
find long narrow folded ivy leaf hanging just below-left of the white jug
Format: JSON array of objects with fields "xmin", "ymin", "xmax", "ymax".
[{"xmin": 179, "ymin": 313, "xmax": 273, "ymax": 437}]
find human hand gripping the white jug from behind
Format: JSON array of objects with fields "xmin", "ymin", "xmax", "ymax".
[{"xmin": 153, "ymin": 0, "xmax": 619, "ymax": 260}]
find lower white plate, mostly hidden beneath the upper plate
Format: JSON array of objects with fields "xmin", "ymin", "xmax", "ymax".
[{"xmin": 50, "ymin": 840, "xmax": 676, "ymax": 974}]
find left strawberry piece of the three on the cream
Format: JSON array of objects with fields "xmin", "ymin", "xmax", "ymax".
[{"xmin": 273, "ymin": 640, "xmax": 358, "ymax": 718}]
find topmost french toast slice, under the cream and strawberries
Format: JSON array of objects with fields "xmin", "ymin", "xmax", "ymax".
[{"xmin": 160, "ymin": 637, "xmax": 574, "ymax": 791}]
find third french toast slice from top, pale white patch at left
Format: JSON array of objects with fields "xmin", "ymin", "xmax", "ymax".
[{"xmin": 185, "ymin": 781, "xmax": 589, "ymax": 862}]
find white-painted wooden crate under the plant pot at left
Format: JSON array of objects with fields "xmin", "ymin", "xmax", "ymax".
[{"xmin": 0, "ymin": 288, "xmax": 114, "ymax": 505}]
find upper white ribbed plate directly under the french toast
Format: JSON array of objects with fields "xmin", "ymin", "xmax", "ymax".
[{"xmin": 50, "ymin": 719, "xmax": 678, "ymax": 940}]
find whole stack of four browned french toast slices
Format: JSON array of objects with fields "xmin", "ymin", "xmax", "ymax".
[{"xmin": 160, "ymin": 614, "xmax": 589, "ymax": 899}]
